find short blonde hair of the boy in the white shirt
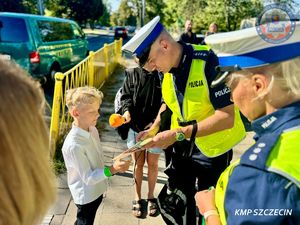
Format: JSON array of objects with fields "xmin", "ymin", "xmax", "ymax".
[{"xmin": 66, "ymin": 87, "xmax": 103, "ymax": 110}]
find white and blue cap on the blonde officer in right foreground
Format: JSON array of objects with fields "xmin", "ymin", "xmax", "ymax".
[{"xmin": 205, "ymin": 22, "xmax": 300, "ymax": 87}]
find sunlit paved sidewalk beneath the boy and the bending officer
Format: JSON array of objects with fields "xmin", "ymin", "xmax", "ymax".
[{"xmin": 42, "ymin": 60, "xmax": 253, "ymax": 225}]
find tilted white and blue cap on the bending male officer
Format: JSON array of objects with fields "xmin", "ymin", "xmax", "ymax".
[{"xmin": 122, "ymin": 16, "xmax": 164, "ymax": 66}]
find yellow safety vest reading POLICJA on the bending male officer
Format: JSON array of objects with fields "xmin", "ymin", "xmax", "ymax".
[{"xmin": 162, "ymin": 45, "xmax": 246, "ymax": 157}]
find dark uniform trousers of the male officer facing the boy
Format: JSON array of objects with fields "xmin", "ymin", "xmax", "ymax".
[{"xmin": 162, "ymin": 141, "xmax": 232, "ymax": 225}]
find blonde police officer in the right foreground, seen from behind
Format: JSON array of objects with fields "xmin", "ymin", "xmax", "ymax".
[{"xmin": 196, "ymin": 21, "xmax": 300, "ymax": 225}]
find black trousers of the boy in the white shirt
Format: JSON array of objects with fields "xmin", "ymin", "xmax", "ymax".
[{"xmin": 74, "ymin": 195, "xmax": 103, "ymax": 225}]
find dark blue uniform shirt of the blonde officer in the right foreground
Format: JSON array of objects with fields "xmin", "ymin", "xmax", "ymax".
[{"xmin": 225, "ymin": 102, "xmax": 300, "ymax": 225}]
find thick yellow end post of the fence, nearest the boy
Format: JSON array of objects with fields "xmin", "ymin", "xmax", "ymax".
[{"xmin": 50, "ymin": 73, "xmax": 65, "ymax": 158}]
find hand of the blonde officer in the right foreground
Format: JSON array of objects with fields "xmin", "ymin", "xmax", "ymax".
[{"xmin": 195, "ymin": 189, "xmax": 216, "ymax": 215}]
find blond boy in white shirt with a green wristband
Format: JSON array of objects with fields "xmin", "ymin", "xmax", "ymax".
[{"xmin": 62, "ymin": 87, "xmax": 130, "ymax": 225}]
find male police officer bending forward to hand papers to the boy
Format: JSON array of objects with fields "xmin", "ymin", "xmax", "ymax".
[{"xmin": 122, "ymin": 16, "xmax": 245, "ymax": 225}]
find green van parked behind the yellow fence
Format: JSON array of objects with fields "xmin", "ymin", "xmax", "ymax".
[{"xmin": 0, "ymin": 13, "xmax": 88, "ymax": 81}]
